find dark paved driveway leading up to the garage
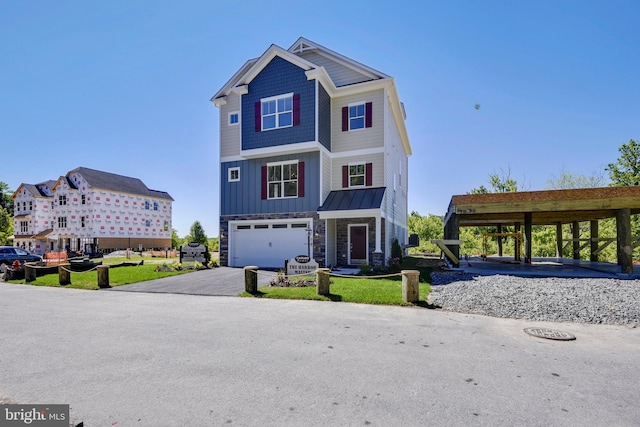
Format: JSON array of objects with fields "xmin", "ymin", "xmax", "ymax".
[{"xmin": 107, "ymin": 267, "xmax": 275, "ymax": 296}]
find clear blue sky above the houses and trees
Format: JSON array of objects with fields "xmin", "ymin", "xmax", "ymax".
[{"xmin": 0, "ymin": 0, "xmax": 640, "ymax": 237}]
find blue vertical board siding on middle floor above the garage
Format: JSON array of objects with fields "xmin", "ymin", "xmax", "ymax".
[{"xmin": 220, "ymin": 152, "xmax": 320, "ymax": 215}]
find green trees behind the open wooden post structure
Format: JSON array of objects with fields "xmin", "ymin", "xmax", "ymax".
[{"xmin": 409, "ymin": 139, "xmax": 640, "ymax": 262}]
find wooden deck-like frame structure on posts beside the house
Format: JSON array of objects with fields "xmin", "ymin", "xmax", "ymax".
[{"xmin": 444, "ymin": 186, "xmax": 640, "ymax": 274}]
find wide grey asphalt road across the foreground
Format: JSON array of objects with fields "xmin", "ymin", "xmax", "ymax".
[{"xmin": 0, "ymin": 284, "xmax": 640, "ymax": 427}]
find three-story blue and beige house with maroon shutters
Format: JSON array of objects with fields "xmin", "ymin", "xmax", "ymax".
[{"xmin": 211, "ymin": 38, "xmax": 411, "ymax": 268}]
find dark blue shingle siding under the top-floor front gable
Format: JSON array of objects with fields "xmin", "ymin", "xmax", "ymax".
[{"xmin": 242, "ymin": 56, "xmax": 315, "ymax": 150}]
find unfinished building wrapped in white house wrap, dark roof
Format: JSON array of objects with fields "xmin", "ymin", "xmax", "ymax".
[{"xmin": 13, "ymin": 167, "xmax": 173, "ymax": 253}]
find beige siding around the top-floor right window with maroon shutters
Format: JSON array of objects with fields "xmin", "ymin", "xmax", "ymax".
[{"xmin": 331, "ymin": 89, "xmax": 385, "ymax": 153}]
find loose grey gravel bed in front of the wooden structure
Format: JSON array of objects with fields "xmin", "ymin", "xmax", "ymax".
[{"xmin": 429, "ymin": 273, "xmax": 640, "ymax": 327}]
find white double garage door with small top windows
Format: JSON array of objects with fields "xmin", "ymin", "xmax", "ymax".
[{"xmin": 229, "ymin": 221, "xmax": 309, "ymax": 268}]
